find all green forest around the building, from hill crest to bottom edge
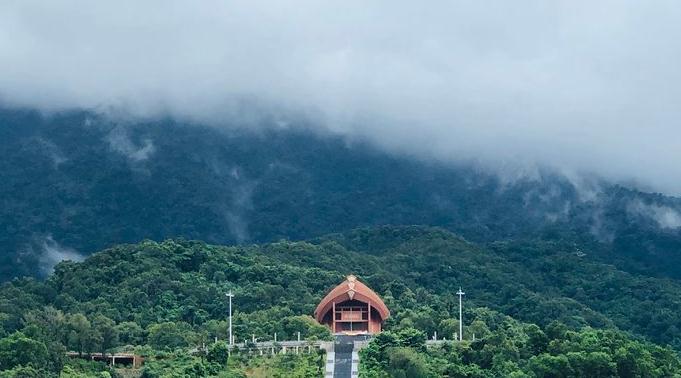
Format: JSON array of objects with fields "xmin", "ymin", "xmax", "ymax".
[{"xmin": 0, "ymin": 226, "xmax": 681, "ymax": 377}]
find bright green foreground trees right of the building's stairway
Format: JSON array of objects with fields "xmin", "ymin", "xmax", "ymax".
[{"xmin": 360, "ymin": 309, "xmax": 681, "ymax": 378}]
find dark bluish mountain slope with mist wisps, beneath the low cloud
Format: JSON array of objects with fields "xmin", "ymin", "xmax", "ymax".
[{"xmin": 0, "ymin": 109, "xmax": 681, "ymax": 279}]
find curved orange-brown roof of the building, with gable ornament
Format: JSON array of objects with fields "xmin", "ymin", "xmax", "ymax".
[{"xmin": 314, "ymin": 275, "xmax": 390, "ymax": 323}]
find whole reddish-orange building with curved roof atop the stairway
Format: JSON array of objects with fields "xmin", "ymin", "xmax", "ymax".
[{"xmin": 314, "ymin": 275, "xmax": 390, "ymax": 335}]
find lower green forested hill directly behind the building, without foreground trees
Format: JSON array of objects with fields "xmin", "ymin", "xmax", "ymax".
[{"xmin": 1, "ymin": 227, "xmax": 681, "ymax": 348}]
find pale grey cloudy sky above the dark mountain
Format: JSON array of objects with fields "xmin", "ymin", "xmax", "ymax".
[{"xmin": 0, "ymin": 0, "xmax": 681, "ymax": 195}]
